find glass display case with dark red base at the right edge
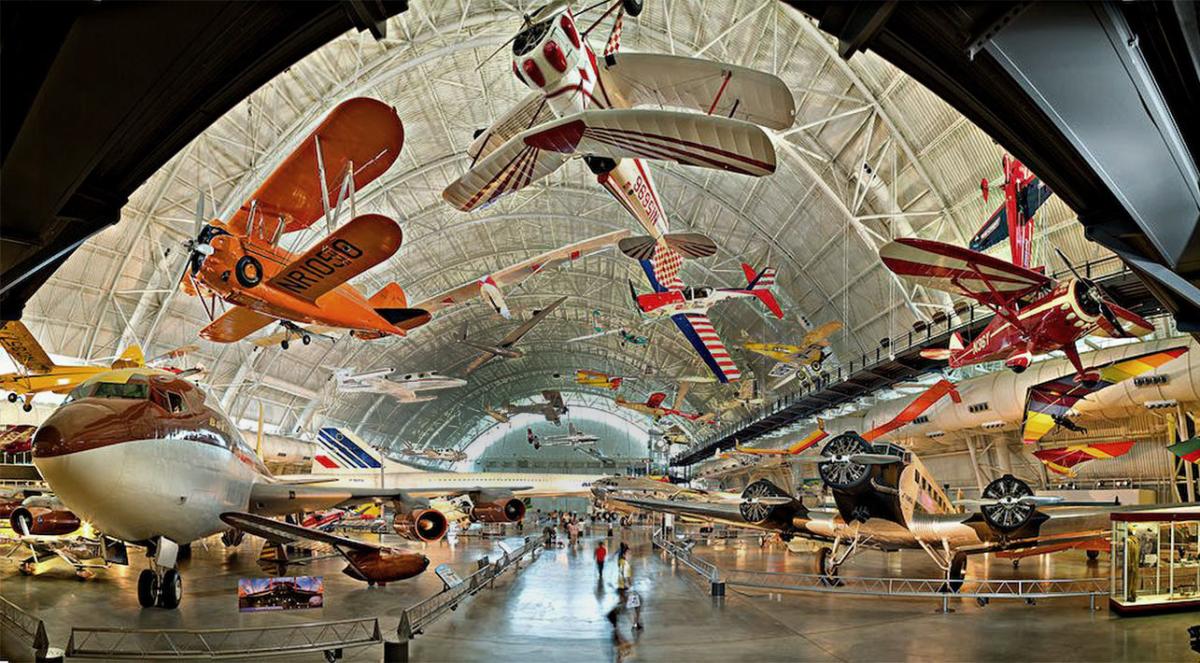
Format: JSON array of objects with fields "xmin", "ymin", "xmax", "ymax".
[{"xmin": 1109, "ymin": 506, "xmax": 1200, "ymax": 615}]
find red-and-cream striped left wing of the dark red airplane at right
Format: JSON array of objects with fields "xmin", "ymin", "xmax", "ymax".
[{"xmin": 880, "ymin": 238, "xmax": 1052, "ymax": 306}]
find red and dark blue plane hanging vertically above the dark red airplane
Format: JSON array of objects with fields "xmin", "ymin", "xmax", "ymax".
[{"xmin": 968, "ymin": 154, "xmax": 1052, "ymax": 268}]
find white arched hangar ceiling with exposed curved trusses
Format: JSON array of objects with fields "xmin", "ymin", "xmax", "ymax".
[{"xmin": 18, "ymin": 0, "xmax": 1099, "ymax": 458}]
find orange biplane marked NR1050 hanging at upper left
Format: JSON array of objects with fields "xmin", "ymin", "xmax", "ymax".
[{"xmin": 175, "ymin": 97, "xmax": 430, "ymax": 348}]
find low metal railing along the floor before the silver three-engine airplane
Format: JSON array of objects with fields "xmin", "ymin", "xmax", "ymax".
[{"xmin": 654, "ymin": 534, "xmax": 1109, "ymax": 611}]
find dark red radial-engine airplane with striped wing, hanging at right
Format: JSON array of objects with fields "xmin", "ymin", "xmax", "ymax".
[{"xmin": 880, "ymin": 238, "xmax": 1154, "ymax": 382}]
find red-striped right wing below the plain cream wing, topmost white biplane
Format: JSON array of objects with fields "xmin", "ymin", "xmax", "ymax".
[{"xmin": 520, "ymin": 108, "xmax": 775, "ymax": 177}]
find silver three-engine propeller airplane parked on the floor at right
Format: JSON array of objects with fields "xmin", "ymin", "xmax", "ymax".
[{"xmin": 606, "ymin": 432, "xmax": 1148, "ymax": 591}]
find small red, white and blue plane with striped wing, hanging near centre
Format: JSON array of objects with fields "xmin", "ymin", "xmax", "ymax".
[{"xmin": 629, "ymin": 261, "xmax": 784, "ymax": 382}]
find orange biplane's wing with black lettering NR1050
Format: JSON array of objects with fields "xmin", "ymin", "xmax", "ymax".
[{"xmin": 268, "ymin": 214, "xmax": 403, "ymax": 301}]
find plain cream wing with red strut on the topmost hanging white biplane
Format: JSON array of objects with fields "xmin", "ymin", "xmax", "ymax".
[{"xmin": 600, "ymin": 53, "xmax": 796, "ymax": 129}]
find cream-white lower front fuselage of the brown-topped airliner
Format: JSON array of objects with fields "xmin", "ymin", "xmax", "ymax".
[{"xmin": 34, "ymin": 438, "xmax": 263, "ymax": 544}]
